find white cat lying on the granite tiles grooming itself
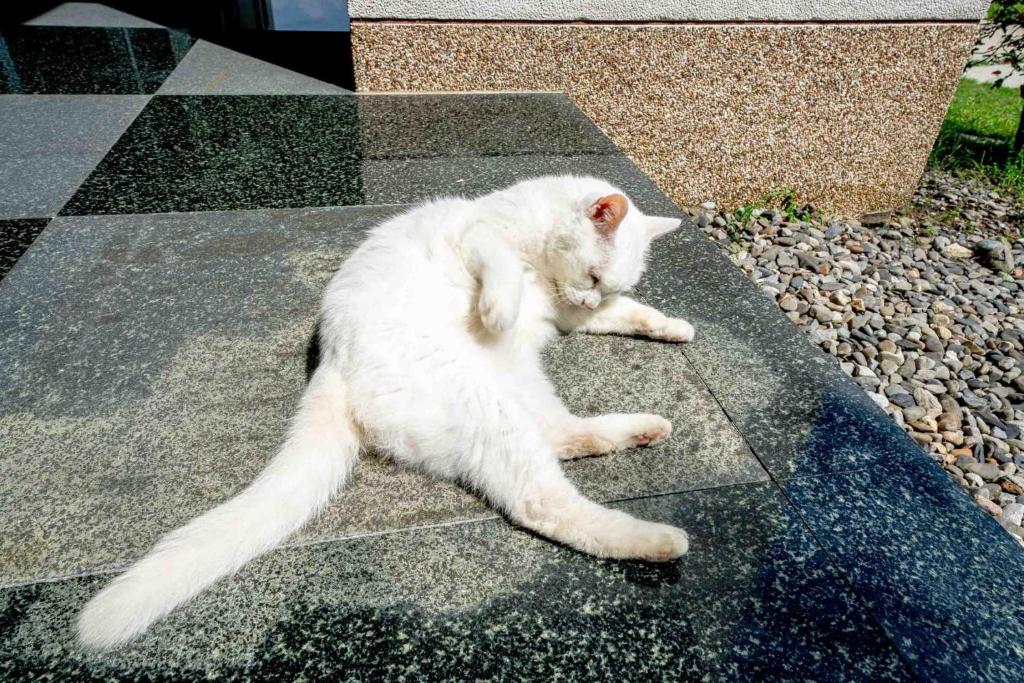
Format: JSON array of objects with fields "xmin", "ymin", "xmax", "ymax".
[{"xmin": 78, "ymin": 177, "xmax": 693, "ymax": 647}]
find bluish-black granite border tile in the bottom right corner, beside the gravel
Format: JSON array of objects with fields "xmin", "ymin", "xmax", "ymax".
[{"xmin": 783, "ymin": 463, "xmax": 1024, "ymax": 682}]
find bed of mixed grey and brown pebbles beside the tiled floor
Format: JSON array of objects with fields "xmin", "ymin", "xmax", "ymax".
[{"xmin": 690, "ymin": 173, "xmax": 1024, "ymax": 545}]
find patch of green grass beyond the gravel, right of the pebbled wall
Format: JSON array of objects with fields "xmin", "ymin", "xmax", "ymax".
[{"xmin": 929, "ymin": 79, "xmax": 1024, "ymax": 200}]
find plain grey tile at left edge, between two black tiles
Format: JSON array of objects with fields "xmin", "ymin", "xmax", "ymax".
[{"xmin": 0, "ymin": 95, "xmax": 148, "ymax": 218}]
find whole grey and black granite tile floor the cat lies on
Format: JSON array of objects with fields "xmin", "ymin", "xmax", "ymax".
[{"xmin": 0, "ymin": 3, "xmax": 1024, "ymax": 681}]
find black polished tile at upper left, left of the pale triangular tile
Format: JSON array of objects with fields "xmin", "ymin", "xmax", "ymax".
[{"xmin": 0, "ymin": 26, "xmax": 193, "ymax": 95}]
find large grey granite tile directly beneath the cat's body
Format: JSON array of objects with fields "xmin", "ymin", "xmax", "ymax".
[{"xmin": 0, "ymin": 207, "xmax": 767, "ymax": 581}]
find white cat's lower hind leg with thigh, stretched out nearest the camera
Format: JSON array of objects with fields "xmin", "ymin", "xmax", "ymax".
[{"xmin": 387, "ymin": 356, "xmax": 688, "ymax": 561}]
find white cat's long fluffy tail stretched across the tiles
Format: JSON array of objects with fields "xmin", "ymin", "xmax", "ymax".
[{"xmin": 78, "ymin": 365, "xmax": 359, "ymax": 648}]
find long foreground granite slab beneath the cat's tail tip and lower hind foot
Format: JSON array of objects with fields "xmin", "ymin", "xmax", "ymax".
[{"xmin": 0, "ymin": 484, "xmax": 912, "ymax": 681}]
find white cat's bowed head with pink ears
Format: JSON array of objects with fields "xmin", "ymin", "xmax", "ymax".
[{"xmin": 544, "ymin": 177, "xmax": 681, "ymax": 308}]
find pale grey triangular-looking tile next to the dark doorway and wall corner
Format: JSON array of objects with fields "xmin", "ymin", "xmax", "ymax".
[{"xmin": 157, "ymin": 40, "xmax": 348, "ymax": 95}]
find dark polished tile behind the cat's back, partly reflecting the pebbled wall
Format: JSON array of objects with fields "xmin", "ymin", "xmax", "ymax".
[{"xmin": 63, "ymin": 94, "xmax": 622, "ymax": 214}]
